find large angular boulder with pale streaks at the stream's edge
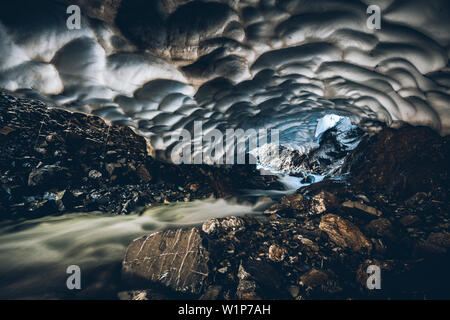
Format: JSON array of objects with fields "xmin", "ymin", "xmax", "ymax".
[{"xmin": 122, "ymin": 228, "xmax": 209, "ymax": 295}]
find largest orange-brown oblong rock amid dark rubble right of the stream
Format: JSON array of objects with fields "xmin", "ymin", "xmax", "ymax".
[{"xmin": 319, "ymin": 214, "xmax": 372, "ymax": 251}]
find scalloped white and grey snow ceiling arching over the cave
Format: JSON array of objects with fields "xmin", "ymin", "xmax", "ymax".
[{"xmin": 0, "ymin": 0, "xmax": 450, "ymax": 159}]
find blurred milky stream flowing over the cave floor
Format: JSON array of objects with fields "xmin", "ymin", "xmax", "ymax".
[{"xmin": 0, "ymin": 199, "xmax": 267, "ymax": 299}]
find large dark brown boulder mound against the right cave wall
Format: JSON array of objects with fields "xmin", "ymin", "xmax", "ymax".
[{"xmin": 342, "ymin": 125, "xmax": 450, "ymax": 199}]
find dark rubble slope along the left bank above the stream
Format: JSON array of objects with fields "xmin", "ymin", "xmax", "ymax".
[{"xmin": 0, "ymin": 92, "xmax": 282, "ymax": 219}]
